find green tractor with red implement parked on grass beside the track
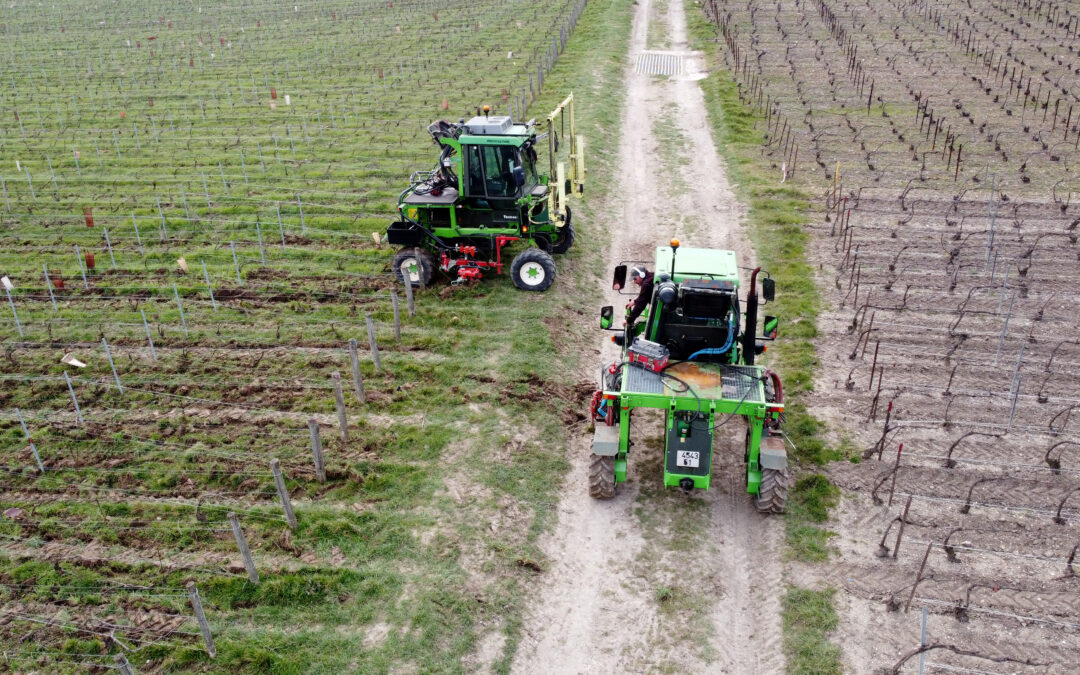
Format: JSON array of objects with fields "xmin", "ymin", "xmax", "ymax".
[{"xmin": 387, "ymin": 94, "xmax": 585, "ymax": 292}]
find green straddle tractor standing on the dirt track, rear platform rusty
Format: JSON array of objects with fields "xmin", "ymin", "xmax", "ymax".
[{"xmin": 589, "ymin": 240, "xmax": 788, "ymax": 513}]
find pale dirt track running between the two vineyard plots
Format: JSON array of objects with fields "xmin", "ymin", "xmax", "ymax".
[{"xmin": 513, "ymin": 0, "xmax": 784, "ymax": 673}]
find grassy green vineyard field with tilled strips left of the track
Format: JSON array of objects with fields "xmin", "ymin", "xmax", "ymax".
[{"xmin": 0, "ymin": 0, "xmax": 629, "ymax": 673}]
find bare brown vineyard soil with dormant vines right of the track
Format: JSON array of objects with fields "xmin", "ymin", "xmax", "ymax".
[{"xmin": 707, "ymin": 0, "xmax": 1080, "ymax": 674}]
